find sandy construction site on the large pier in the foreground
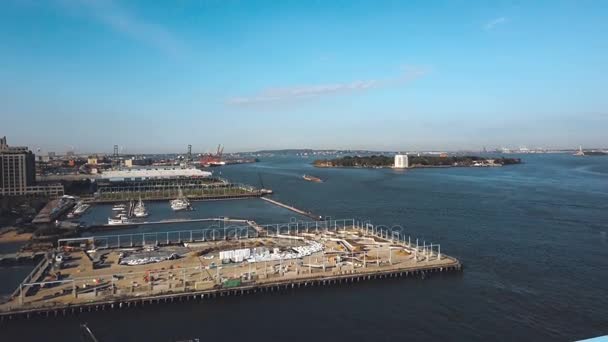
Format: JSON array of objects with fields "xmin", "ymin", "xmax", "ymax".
[{"xmin": 0, "ymin": 220, "xmax": 461, "ymax": 318}]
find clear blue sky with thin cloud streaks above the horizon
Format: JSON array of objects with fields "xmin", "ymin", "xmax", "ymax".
[{"xmin": 0, "ymin": 0, "xmax": 608, "ymax": 153}]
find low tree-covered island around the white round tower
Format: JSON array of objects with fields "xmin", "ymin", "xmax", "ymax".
[{"xmin": 313, "ymin": 155, "xmax": 521, "ymax": 168}]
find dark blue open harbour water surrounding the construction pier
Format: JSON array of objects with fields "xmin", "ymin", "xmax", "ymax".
[{"xmin": 2, "ymin": 155, "xmax": 608, "ymax": 341}]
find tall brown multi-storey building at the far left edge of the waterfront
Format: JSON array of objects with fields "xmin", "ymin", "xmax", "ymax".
[{"xmin": 0, "ymin": 137, "xmax": 63, "ymax": 196}]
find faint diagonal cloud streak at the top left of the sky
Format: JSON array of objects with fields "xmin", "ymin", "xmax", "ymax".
[{"xmin": 61, "ymin": 0, "xmax": 183, "ymax": 56}]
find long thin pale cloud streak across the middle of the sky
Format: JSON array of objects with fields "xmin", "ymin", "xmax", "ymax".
[{"xmin": 226, "ymin": 66, "xmax": 427, "ymax": 106}]
